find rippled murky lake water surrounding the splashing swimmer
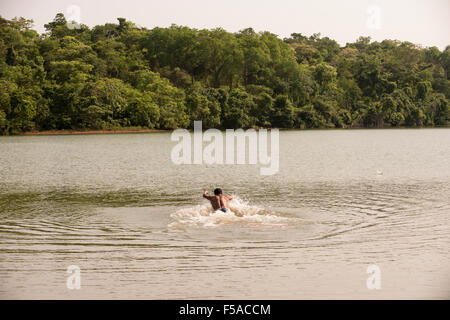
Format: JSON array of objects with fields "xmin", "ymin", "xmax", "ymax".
[{"xmin": 0, "ymin": 129, "xmax": 450, "ymax": 299}]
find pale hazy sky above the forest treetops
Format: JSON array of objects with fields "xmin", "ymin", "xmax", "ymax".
[{"xmin": 0, "ymin": 0, "xmax": 450, "ymax": 50}]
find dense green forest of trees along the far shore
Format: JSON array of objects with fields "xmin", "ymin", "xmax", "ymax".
[{"xmin": 0, "ymin": 14, "xmax": 450, "ymax": 134}]
